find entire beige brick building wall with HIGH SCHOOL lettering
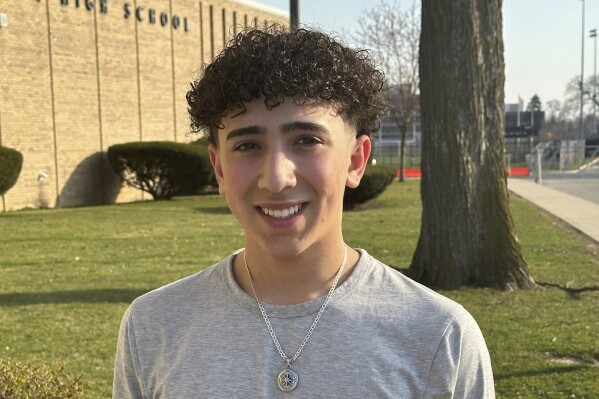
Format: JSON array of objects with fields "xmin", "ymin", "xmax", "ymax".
[{"xmin": 0, "ymin": 0, "xmax": 288, "ymax": 211}]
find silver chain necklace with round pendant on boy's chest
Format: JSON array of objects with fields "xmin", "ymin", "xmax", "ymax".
[{"xmin": 243, "ymin": 246, "xmax": 347, "ymax": 392}]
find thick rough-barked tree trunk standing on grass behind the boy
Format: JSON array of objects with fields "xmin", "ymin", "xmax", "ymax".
[{"xmin": 408, "ymin": 0, "xmax": 534, "ymax": 289}]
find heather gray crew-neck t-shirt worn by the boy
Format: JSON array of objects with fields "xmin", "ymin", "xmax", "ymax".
[{"xmin": 113, "ymin": 250, "xmax": 495, "ymax": 399}]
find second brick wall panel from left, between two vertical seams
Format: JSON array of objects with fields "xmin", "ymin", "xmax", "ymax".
[{"xmin": 50, "ymin": 4, "xmax": 101, "ymax": 206}]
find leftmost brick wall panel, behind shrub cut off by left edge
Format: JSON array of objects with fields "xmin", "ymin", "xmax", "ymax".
[{"xmin": 0, "ymin": 1, "xmax": 57, "ymax": 209}]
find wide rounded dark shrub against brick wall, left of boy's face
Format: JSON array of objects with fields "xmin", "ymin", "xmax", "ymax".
[{"xmin": 107, "ymin": 141, "xmax": 212, "ymax": 200}]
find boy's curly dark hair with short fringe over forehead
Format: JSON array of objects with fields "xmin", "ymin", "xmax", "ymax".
[{"xmin": 186, "ymin": 26, "xmax": 386, "ymax": 142}]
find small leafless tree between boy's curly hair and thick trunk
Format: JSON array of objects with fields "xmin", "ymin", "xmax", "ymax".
[{"xmin": 353, "ymin": 0, "xmax": 420, "ymax": 181}]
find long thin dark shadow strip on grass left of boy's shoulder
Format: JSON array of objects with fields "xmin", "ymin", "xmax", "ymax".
[{"xmin": 0, "ymin": 289, "xmax": 148, "ymax": 307}]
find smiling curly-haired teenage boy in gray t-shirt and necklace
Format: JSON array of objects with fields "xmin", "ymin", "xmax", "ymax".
[{"xmin": 114, "ymin": 30, "xmax": 494, "ymax": 398}]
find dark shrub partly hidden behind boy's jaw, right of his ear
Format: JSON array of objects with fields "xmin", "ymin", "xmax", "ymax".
[{"xmin": 343, "ymin": 165, "xmax": 396, "ymax": 210}]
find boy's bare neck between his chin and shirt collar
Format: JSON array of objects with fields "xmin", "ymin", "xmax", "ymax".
[{"xmin": 233, "ymin": 243, "xmax": 359, "ymax": 305}]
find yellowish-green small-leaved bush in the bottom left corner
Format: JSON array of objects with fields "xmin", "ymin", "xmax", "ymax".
[{"xmin": 0, "ymin": 359, "xmax": 83, "ymax": 399}]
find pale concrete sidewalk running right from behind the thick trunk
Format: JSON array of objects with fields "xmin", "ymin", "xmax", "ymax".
[{"xmin": 508, "ymin": 178, "xmax": 599, "ymax": 243}]
